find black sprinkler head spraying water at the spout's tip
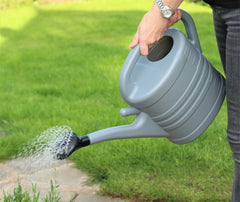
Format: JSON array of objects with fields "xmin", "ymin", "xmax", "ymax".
[{"xmin": 53, "ymin": 132, "xmax": 90, "ymax": 160}]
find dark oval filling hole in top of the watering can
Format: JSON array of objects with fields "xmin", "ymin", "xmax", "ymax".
[{"xmin": 147, "ymin": 36, "xmax": 173, "ymax": 62}]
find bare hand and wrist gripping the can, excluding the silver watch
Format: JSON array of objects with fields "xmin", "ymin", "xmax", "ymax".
[{"xmin": 129, "ymin": 0, "xmax": 183, "ymax": 55}]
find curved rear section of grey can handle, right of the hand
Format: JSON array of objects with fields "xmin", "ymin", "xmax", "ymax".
[{"xmin": 179, "ymin": 9, "xmax": 202, "ymax": 52}]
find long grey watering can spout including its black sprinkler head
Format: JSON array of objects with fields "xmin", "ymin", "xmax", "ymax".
[{"xmin": 53, "ymin": 107, "xmax": 169, "ymax": 160}]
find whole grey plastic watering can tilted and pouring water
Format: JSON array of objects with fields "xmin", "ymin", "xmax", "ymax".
[{"xmin": 55, "ymin": 10, "xmax": 225, "ymax": 159}]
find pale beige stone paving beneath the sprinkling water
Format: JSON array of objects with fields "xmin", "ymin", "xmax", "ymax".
[{"xmin": 0, "ymin": 158, "xmax": 126, "ymax": 202}]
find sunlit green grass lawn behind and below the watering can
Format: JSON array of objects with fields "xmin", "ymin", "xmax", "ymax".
[{"xmin": 0, "ymin": 0, "xmax": 233, "ymax": 201}]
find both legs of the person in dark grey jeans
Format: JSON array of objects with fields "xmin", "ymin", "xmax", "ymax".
[{"xmin": 214, "ymin": 7, "xmax": 240, "ymax": 202}]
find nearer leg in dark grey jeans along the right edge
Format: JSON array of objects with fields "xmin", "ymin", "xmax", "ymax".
[{"xmin": 226, "ymin": 9, "xmax": 240, "ymax": 202}]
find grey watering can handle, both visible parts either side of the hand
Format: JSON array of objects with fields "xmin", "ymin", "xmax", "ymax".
[{"xmin": 119, "ymin": 9, "xmax": 202, "ymax": 96}]
